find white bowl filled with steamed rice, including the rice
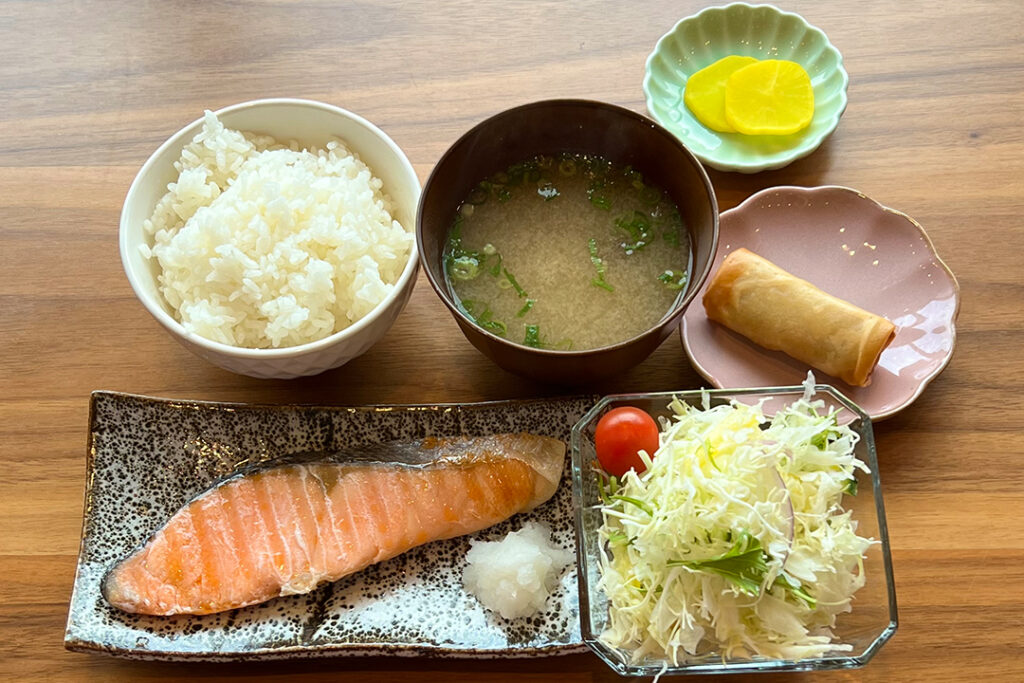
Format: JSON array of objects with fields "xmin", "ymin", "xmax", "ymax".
[{"xmin": 120, "ymin": 98, "xmax": 420, "ymax": 378}]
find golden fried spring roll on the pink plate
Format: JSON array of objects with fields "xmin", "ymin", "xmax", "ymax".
[{"xmin": 703, "ymin": 249, "xmax": 896, "ymax": 386}]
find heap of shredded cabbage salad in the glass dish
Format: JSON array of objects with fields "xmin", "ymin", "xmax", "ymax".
[{"xmin": 599, "ymin": 390, "xmax": 873, "ymax": 666}]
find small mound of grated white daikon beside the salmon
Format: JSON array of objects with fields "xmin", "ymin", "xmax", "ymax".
[{"xmin": 462, "ymin": 521, "xmax": 573, "ymax": 618}]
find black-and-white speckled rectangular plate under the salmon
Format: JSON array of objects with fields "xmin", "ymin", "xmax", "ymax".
[{"xmin": 65, "ymin": 391, "xmax": 597, "ymax": 660}]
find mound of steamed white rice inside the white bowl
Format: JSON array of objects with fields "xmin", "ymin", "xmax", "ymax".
[{"xmin": 143, "ymin": 112, "xmax": 414, "ymax": 348}]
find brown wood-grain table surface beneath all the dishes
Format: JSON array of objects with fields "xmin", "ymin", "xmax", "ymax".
[{"xmin": 0, "ymin": 0, "xmax": 1024, "ymax": 683}]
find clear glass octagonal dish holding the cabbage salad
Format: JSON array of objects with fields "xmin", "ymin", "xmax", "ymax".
[{"xmin": 571, "ymin": 384, "xmax": 897, "ymax": 676}]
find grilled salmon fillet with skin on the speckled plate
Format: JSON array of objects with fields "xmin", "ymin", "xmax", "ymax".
[{"xmin": 102, "ymin": 433, "xmax": 565, "ymax": 615}]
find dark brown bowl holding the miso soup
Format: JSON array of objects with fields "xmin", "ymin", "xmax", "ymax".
[{"xmin": 416, "ymin": 99, "xmax": 718, "ymax": 385}]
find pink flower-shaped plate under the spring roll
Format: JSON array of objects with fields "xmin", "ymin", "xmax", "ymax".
[{"xmin": 681, "ymin": 185, "xmax": 959, "ymax": 420}]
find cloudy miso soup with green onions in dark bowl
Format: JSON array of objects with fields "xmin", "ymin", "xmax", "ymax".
[{"xmin": 444, "ymin": 154, "xmax": 690, "ymax": 350}]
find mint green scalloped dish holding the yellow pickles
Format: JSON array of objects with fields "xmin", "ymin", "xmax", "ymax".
[{"xmin": 643, "ymin": 2, "xmax": 850, "ymax": 173}]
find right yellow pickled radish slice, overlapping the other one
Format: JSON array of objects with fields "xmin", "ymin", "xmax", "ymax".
[{"xmin": 725, "ymin": 59, "xmax": 814, "ymax": 135}]
